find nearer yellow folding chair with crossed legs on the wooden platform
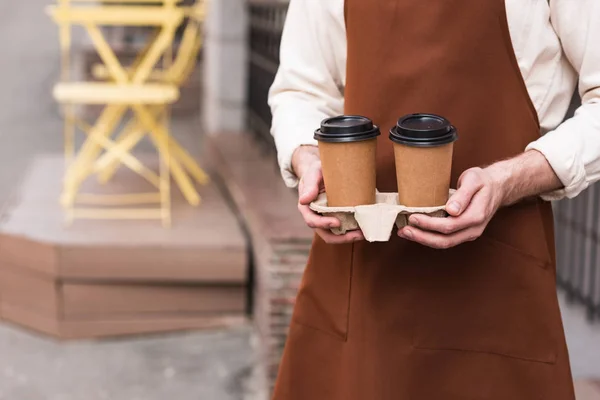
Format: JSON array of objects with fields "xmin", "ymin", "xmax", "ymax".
[{"xmin": 49, "ymin": 0, "xmax": 188, "ymax": 226}]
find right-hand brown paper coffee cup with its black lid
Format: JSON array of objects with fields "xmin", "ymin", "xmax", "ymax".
[{"xmin": 390, "ymin": 114, "xmax": 458, "ymax": 207}]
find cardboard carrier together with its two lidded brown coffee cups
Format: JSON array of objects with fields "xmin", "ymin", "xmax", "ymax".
[{"xmin": 310, "ymin": 114, "xmax": 458, "ymax": 242}]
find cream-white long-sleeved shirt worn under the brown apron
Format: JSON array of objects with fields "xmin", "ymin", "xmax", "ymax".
[{"xmin": 269, "ymin": 0, "xmax": 600, "ymax": 200}]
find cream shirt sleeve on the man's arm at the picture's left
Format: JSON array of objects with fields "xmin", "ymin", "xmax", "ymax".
[{"xmin": 269, "ymin": 0, "xmax": 345, "ymax": 187}]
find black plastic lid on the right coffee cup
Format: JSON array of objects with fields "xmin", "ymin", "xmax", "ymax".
[{"xmin": 390, "ymin": 114, "xmax": 458, "ymax": 147}]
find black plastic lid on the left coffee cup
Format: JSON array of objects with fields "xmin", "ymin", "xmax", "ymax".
[{"xmin": 315, "ymin": 115, "xmax": 381, "ymax": 143}]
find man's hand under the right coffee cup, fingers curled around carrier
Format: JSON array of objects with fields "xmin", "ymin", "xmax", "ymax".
[{"xmin": 398, "ymin": 168, "xmax": 505, "ymax": 249}]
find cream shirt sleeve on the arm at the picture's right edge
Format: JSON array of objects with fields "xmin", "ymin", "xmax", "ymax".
[{"xmin": 527, "ymin": 0, "xmax": 600, "ymax": 200}]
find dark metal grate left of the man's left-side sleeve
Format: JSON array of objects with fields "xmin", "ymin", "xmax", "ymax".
[{"xmin": 248, "ymin": 0, "xmax": 288, "ymax": 155}]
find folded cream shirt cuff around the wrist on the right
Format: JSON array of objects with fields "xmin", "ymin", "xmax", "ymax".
[{"xmin": 525, "ymin": 127, "xmax": 589, "ymax": 201}]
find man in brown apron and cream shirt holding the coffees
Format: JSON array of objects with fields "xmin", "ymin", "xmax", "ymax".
[{"xmin": 270, "ymin": 0, "xmax": 600, "ymax": 400}]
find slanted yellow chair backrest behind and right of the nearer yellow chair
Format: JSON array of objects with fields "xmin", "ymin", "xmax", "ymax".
[{"xmin": 163, "ymin": 0, "xmax": 206, "ymax": 86}]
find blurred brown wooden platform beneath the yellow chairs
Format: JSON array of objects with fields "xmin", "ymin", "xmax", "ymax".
[{"xmin": 0, "ymin": 156, "xmax": 248, "ymax": 338}]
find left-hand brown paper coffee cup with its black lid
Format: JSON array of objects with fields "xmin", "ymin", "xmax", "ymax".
[{"xmin": 315, "ymin": 115, "xmax": 381, "ymax": 207}]
